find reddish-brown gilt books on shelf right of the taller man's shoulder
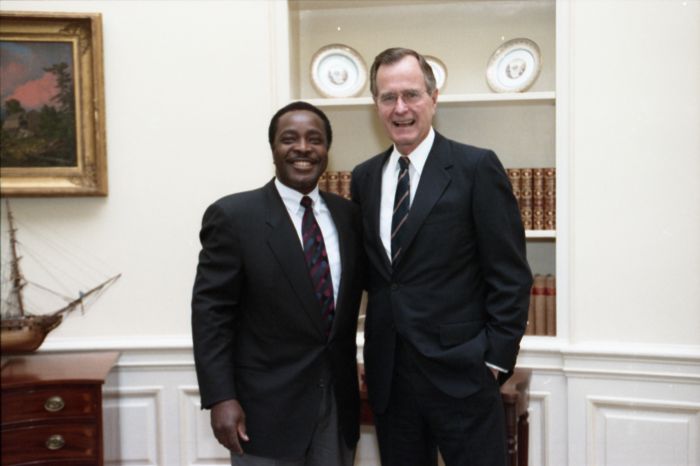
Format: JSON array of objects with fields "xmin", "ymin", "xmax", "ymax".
[{"xmin": 506, "ymin": 167, "xmax": 557, "ymax": 230}]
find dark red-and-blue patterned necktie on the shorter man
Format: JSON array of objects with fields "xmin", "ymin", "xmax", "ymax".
[{"xmin": 301, "ymin": 196, "xmax": 335, "ymax": 335}]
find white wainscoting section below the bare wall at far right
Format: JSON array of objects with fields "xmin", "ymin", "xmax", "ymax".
[{"xmin": 564, "ymin": 342, "xmax": 700, "ymax": 466}]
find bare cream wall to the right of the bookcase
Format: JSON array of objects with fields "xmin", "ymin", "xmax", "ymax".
[{"xmin": 570, "ymin": 0, "xmax": 700, "ymax": 345}]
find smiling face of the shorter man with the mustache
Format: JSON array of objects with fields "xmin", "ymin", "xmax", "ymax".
[{"xmin": 272, "ymin": 110, "xmax": 328, "ymax": 194}]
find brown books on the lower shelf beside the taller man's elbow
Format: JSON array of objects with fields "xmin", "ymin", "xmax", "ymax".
[{"xmin": 525, "ymin": 274, "xmax": 557, "ymax": 336}]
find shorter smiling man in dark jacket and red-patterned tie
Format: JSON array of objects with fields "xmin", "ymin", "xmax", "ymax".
[{"xmin": 192, "ymin": 102, "xmax": 363, "ymax": 466}]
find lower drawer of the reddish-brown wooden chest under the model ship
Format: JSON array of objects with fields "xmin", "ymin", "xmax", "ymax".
[{"xmin": 2, "ymin": 424, "xmax": 100, "ymax": 466}]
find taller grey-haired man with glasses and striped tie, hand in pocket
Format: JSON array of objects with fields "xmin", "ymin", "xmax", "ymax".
[{"xmin": 352, "ymin": 49, "xmax": 532, "ymax": 466}]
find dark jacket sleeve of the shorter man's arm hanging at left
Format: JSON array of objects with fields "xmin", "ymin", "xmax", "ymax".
[{"xmin": 192, "ymin": 204, "xmax": 243, "ymax": 409}]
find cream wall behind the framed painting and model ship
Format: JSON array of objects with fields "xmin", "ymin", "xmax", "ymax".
[{"xmin": 2, "ymin": 0, "xmax": 276, "ymax": 343}]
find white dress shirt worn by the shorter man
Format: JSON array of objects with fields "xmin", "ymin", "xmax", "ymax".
[{"xmin": 275, "ymin": 178, "xmax": 341, "ymax": 302}]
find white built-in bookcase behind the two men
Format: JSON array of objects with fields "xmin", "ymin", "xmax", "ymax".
[{"xmin": 277, "ymin": 0, "xmax": 567, "ymax": 347}]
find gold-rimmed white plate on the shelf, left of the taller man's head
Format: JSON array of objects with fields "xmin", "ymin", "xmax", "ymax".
[{"xmin": 311, "ymin": 44, "xmax": 367, "ymax": 97}]
